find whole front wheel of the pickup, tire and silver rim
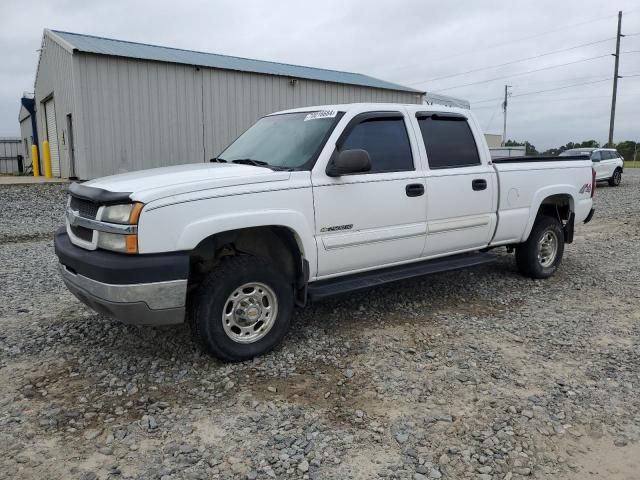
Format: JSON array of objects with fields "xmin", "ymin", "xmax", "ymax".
[{"xmin": 189, "ymin": 256, "xmax": 293, "ymax": 362}]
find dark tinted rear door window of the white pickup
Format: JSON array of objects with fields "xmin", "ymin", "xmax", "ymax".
[{"xmin": 418, "ymin": 117, "xmax": 480, "ymax": 169}]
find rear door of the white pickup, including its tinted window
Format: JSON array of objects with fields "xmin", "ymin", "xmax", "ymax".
[{"xmin": 416, "ymin": 112, "xmax": 497, "ymax": 257}]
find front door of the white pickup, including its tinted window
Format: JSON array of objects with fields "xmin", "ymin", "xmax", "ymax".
[{"xmin": 312, "ymin": 112, "xmax": 426, "ymax": 277}]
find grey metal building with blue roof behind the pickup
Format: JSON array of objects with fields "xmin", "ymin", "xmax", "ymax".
[{"xmin": 27, "ymin": 30, "xmax": 424, "ymax": 179}]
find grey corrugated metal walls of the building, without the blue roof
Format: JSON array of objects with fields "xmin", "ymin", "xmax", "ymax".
[{"xmin": 36, "ymin": 35, "xmax": 421, "ymax": 179}]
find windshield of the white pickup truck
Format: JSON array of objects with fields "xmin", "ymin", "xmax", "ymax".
[{"xmin": 217, "ymin": 110, "xmax": 340, "ymax": 169}]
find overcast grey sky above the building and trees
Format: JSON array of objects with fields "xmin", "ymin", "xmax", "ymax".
[{"xmin": 0, "ymin": 0, "xmax": 640, "ymax": 149}]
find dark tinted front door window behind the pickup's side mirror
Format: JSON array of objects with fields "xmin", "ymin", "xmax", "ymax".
[{"xmin": 340, "ymin": 117, "xmax": 413, "ymax": 173}]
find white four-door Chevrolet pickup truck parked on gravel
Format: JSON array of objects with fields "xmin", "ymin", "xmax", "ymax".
[{"xmin": 55, "ymin": 104, "xmax": 595, "ymax": 361}]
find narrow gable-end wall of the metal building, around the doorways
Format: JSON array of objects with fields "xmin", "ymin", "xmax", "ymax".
[{"xmin": 35, "ymin": 35, "xmax": 75, "ymax": 177}]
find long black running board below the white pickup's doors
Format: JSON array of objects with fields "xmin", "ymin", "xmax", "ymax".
[{"xmin": 307, "ymin": 252, "xmax": 497, "ymax": 301}]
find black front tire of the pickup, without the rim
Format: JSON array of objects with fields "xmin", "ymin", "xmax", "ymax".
[{"xmin": 188, "ymin": 255, "xmax": 294, "ymax": 362}]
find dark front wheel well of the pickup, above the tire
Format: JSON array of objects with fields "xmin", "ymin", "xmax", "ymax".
[{"xmin": 189, "ymin": 226, "xmax": 306, "ymax": 287}]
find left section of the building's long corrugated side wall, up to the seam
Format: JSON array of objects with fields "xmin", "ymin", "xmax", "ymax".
[{"xmin": 74, "ymin": 54, "xmax": 203, "ymax": 178}]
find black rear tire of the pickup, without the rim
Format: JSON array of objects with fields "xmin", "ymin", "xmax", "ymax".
[{"xmin": 516, "ymin": 215, "xmax": 564, "ymax": 278}]
